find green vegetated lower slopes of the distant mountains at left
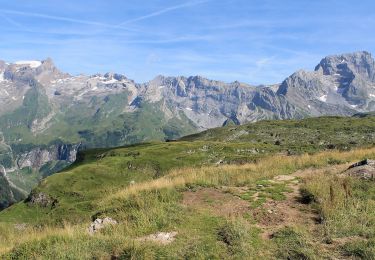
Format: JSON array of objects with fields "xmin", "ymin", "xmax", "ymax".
[{"xmin": 0, "ymin": 90, "xmax": 196, "ymax": 204}]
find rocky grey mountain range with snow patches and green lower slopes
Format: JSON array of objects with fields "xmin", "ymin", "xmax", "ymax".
[{"xmin": 0, "ymin": 52, "xmax": 375, "ymax": 207}]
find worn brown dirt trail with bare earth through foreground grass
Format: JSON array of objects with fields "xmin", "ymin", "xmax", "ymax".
[{"xmin": 183, "ymin": 164, "xmax": 360, "ymax": 259}]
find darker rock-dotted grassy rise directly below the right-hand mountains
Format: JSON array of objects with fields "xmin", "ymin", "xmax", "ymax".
[{"xmin": 182, "ymin": 116, "xmax": 375, "ymax": 151}]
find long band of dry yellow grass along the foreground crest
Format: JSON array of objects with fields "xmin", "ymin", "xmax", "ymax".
[{"xmin": 102, "ymin": 148, "xmax": 375, "ymax": 205}]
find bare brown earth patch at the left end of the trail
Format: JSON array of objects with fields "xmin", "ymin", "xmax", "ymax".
[{"xmin": 182, "ymin": 188, "xmax": 249, "ymax": 217}]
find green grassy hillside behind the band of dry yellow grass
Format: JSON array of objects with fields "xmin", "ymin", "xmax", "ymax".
[{"xmin": 0, "ymin": 114, "xmax": 375, "ymax": 222}]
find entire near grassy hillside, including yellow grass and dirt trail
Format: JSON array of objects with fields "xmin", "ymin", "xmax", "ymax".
[{"xmin": 0, "ymin": 116, "xmax": 375, "ymax": 259}]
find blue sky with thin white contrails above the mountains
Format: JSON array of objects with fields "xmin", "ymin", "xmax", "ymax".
[{"xmin": 0, "ymin": 0, "xmax": 375, "ymax": 84}]
